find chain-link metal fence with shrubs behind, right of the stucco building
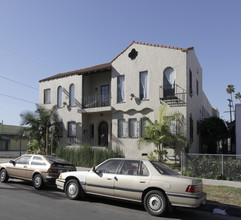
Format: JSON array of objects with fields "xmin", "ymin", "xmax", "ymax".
[{"xmin": 181, "ymin": 153, "xmax": 241, "ymax": 181}]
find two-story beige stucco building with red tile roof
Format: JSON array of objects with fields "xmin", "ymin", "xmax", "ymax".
[{"xmin": 39, "ymin": 41, "xmax": 217, "ymax": 157}]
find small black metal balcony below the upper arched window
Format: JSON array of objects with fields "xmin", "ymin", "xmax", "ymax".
[{"xmin": 159, "ymin": 84, "xmax": 187, "ymax": 107}]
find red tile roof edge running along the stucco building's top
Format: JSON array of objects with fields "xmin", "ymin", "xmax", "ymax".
[{"xmin": 39, "ymin": 41, "xmax": 194, "ymax": 82}]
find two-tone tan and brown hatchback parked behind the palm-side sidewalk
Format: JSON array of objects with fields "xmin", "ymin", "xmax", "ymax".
[{"xmin": 0, "ymin": 154, "xmax": 76, "ymax": 189}]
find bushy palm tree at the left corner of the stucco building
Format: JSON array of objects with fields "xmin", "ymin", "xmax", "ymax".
[{"xmin": 20, "ymin": 104, "xmax": 59, "ymax": 154}]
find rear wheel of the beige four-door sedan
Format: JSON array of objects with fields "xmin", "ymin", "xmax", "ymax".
[{"xmin": 144, "ymin": 190, "xmax": 168, "ymax": 216}]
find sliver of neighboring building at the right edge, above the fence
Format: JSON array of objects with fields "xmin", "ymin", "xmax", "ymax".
[{"xmin": 235, "ymin": 104, "xmax": 241, "ymax": 155}]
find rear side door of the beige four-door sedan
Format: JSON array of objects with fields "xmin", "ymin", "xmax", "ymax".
[{"xmin": 114, "ymin": 160, "xmax": 150, "ymax": 201}]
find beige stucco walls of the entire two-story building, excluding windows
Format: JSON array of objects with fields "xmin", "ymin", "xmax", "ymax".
[{"xmin": 39, "ymin": 43, "xmax": 216, "ymax": 158}]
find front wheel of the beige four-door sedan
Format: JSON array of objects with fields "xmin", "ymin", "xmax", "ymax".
[{"xmin": 65, "ymin": 179, "xmax": 82, "ymax": 200}]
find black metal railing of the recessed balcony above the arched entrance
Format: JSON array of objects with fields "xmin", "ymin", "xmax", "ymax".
[{"xmin": 83, "ymin": 94, "xmax": 110, "ymax": 108}]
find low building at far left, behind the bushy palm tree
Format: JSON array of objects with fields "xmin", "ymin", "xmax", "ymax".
[{"xmin": 0, "ymin": 124, "xmax": 28, "ymax": 155}]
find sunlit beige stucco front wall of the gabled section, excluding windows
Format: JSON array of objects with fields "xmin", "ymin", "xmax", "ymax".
[{"xmin": 111, "ymin": 44, "xmax": 187, "ymax": 157}]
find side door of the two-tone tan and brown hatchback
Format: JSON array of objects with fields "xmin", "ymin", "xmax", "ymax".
[{"xmin": 7, "ymin": 155, "xmax": 32, "ymax": 179}]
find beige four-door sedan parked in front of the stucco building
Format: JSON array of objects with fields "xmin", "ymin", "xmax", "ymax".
[{"xmin": 56, "ymin": 158, "xmax": 206, "ymax": 216}]
